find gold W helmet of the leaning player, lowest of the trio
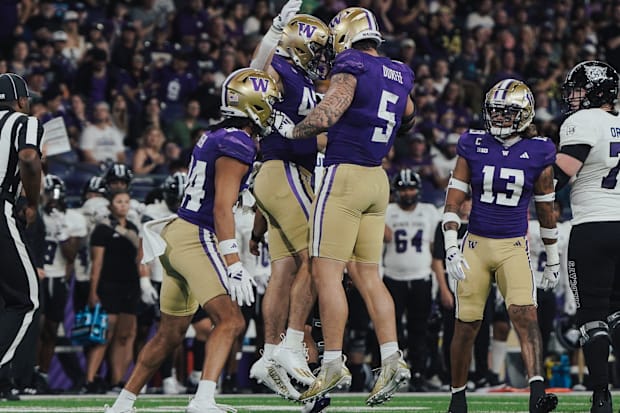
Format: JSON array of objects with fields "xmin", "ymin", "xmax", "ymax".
[{"xmin": 220, "ymin": 68, "xmax": 282, "ymax": 136}]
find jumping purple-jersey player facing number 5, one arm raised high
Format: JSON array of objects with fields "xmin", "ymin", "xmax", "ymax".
[{"xmin": 250, "ymin": 0, "xmax": 330, "ymax": 399}]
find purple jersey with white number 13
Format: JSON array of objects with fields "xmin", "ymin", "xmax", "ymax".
[{"xmin": 457, "ymin": 130, "xmax": 555, "ymax": 238}]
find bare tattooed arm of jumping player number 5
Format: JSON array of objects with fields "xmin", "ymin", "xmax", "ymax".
[{"xmin": 293, "ymin": 73, "xmax": 357, "ymax": 139}]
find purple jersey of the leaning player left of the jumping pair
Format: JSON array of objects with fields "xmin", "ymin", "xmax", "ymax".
[{"xmin": 177, "ymin": 128, "xmax": 256, "ymax": 232}]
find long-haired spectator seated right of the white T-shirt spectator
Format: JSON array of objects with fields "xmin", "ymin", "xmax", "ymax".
[{"xmin": 132, "ymin": 126, "xmax": 168, "ymax": 175}]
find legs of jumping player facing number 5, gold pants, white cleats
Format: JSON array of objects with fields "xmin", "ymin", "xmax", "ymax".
[{"xmin": 250, "ymin": 161, "xmax": 315, "ymax": 386}]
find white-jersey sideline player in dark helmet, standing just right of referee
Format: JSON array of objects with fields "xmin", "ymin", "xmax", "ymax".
[{"xmin": 38, "ymin": 175, "xmax": 87, "ymax": 384}]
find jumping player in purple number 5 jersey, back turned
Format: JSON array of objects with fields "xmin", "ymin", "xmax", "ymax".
[{"xmin": 276, "ymin": 7, "xmax": 414, "ymax": 406}]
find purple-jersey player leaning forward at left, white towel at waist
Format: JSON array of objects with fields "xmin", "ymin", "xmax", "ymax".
[{"xmin": 106, "ymin": 69, "xmax": 280, "ymax": 413}]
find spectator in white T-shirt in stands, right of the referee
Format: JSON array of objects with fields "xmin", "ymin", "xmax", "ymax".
[{"xmin": 80, "ymin": 102, "xmax": 125, "ymax": 165}]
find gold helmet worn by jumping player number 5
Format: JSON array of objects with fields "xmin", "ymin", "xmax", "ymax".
[{"xmin": 329, "ymin": 7, "xmax": 383, "ymax": 54}]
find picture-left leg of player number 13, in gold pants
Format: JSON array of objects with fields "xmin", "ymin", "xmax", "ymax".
[{"xmin": 449, "ymin": 234, "xmax": 494, "ymax": 413}]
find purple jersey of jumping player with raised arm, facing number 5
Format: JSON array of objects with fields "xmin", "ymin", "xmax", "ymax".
[{"xmin": 260, "ymin": 55, "xmax": 317, "ymax": 172}]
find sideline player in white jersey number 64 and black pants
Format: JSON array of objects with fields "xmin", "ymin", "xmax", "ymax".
[{"xmin": 383, "ymin": 169, "xmax": 441, "ymax": 390}]
